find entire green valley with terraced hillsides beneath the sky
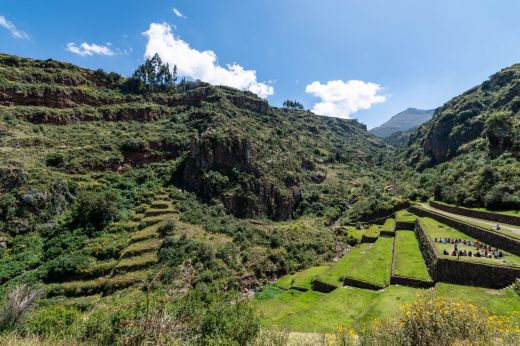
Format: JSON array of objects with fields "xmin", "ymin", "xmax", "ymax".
[{"xmin": 0, "ymin": 50, "xmax": 520, "ymax": 345}]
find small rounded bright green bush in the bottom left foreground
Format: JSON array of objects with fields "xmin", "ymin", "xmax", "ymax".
[{"xmin": 25, "ymin": 305, "xmax": 81, "ymax": 337}]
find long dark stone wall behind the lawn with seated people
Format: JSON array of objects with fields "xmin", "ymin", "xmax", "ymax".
[{"xmin": 409, "ymin": 207, "xmax": 520, "ymax": 256}]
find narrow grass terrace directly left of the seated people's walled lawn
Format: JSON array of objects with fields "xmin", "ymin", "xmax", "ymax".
[{"xmin": 394, "ymin": 231, "xmax": 431, "ymax": 281}]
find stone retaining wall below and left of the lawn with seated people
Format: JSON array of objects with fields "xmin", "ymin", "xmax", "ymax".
[{"xmin": 416, "ymin": 220, "xmax": 520, "ymax": 288}]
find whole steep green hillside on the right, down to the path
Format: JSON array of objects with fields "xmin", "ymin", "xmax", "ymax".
[{"xmin": 402, "ymin": 64, "xmax": 520, "ymax": 209}]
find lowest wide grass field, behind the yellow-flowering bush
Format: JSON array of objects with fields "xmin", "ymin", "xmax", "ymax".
[{"xmin": 254, "ymin": 283, "xmax": 520, "ymax": 333}]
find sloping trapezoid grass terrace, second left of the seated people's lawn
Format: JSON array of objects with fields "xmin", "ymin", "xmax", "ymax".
[{"xmin": 347, "ymin": 237, "xmax": 394, "ymax": 287}]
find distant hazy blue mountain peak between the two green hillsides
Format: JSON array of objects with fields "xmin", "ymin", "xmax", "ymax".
[{"xmin": 370, "ymin": 108, "xmax": 435, "ymax": 138}]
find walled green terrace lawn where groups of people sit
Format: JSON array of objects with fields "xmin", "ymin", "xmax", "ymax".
[{"xmin": 420, "ymin": 217, "xmax": 520, "ymax": 267}]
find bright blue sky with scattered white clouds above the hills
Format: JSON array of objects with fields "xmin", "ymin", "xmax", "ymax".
[{"xmin": 0, "ymin": 0, "xmax": 520, "ymax": 128}]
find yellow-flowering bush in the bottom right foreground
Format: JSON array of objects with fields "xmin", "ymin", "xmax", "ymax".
[{"xmin": 361, "ymin": 297, "xmax": 520, "ymax": 346}]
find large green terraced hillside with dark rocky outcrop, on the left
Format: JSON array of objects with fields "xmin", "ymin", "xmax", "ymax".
[{"xmin": 0, "ymin": 54, "xmax": 405, "ymax": 297}]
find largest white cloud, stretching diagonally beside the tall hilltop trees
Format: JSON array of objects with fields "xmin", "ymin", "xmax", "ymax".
[{"xmin": 143, "ymin": 23, "xmax": 274, "ymax": 98}]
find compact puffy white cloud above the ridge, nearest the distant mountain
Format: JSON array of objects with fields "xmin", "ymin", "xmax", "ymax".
[{"xmin": 305, "ymin": 80, "xmax": 386, "ymax": 118}]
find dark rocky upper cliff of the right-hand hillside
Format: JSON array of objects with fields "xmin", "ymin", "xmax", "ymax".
[{"xmin": 406, "ymin": 65, "xmax": 520, "ymax": 168}]
